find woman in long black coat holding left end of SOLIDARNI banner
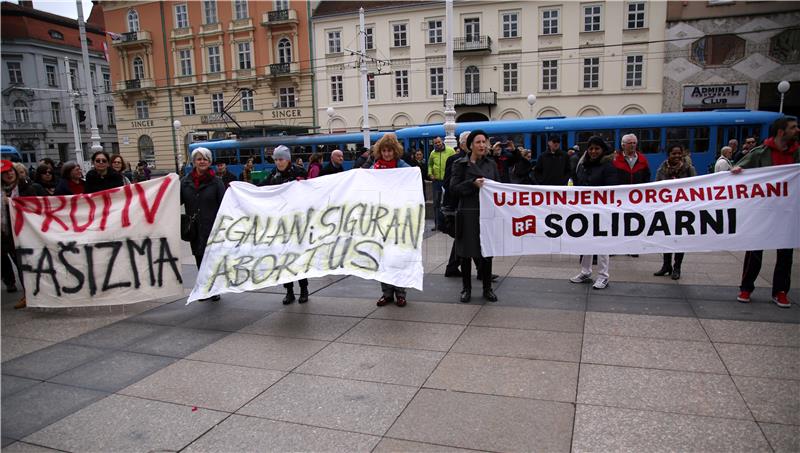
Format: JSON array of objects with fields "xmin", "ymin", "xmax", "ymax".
[{"xmin": 450, "ymin": 130, "xmax": 500, "ymax": 303}]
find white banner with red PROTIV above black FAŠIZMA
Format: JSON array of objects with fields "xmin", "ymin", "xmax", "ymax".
[{"xmin": 11, "ymin": 173, "xmax": 183, "ymax": 307}]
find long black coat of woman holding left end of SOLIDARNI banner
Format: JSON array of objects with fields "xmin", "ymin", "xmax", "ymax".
[{"xmin": 450, "ymin": 156, "xmax": 500, "ymax": 258}]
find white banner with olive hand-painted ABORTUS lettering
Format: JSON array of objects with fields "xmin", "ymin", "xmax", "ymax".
[{"xmin": 189, "ymin": 168, "xmax": 425, "ymax": 302}]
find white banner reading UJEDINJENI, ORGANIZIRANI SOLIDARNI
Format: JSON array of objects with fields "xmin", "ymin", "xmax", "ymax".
[{"xmin": 480, "ymin": 164, "xmax": 800, "ymax": 256}]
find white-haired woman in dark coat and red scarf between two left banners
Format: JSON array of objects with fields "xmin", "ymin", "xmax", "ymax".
[{"xmin": 181, "ymin": 148, "xmax": 225, "ymax": 301}]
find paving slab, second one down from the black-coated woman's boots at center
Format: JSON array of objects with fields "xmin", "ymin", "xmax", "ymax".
[{"xmin": 452, "ymin": 326, "xmax": 581, "ymax": 362}]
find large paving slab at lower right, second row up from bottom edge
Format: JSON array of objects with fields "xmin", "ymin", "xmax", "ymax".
[{"xmin": 578, "ymin": 364, "xmax": 753, "ymax": 420}]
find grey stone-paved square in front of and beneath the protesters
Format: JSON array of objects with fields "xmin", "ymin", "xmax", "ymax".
[{"xmin": 0, "ymin": 230, "xmax": 800, "ymax": 452}]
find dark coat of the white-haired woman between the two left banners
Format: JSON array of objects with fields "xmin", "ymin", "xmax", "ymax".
[{"xmin": 181, "ymin": 173, "xmax": 225, "ymax": 257}]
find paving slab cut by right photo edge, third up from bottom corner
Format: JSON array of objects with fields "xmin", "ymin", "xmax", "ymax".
[{"xmin": 716, "ymin": 343, "xmax": 800, "ymax": 379}]
